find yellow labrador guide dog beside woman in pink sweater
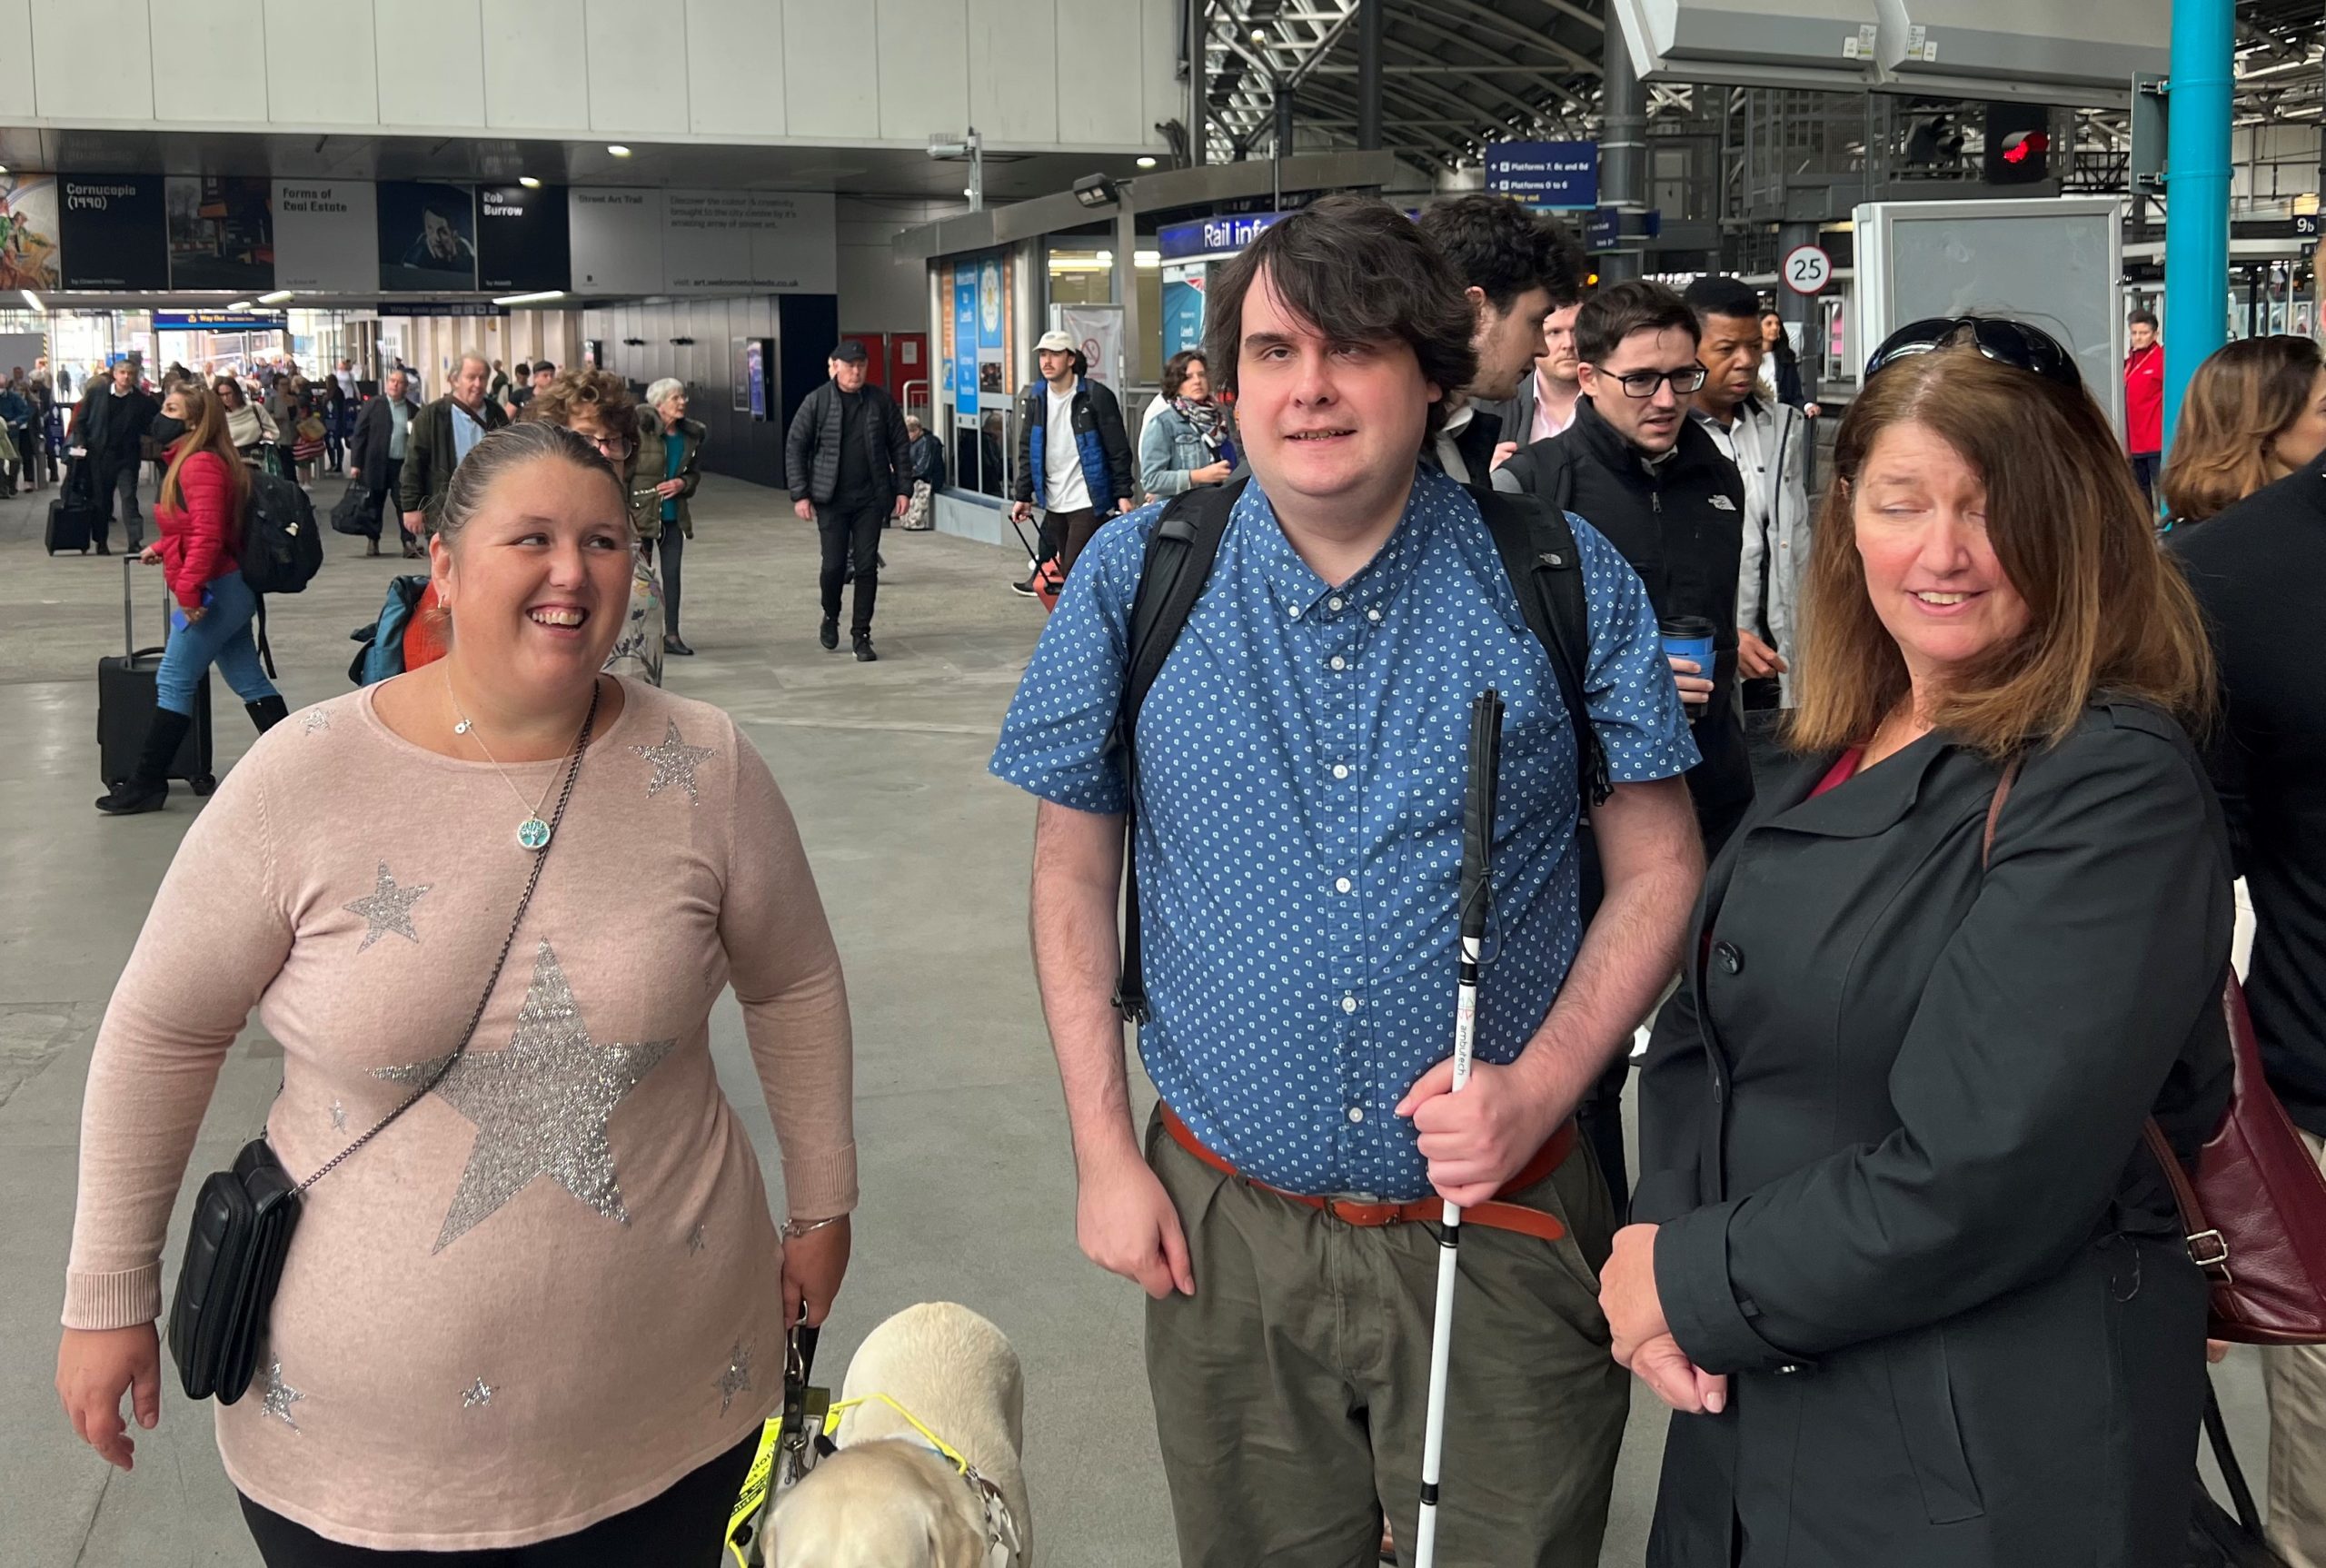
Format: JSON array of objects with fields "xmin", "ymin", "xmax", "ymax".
[{"xmin": 768, "ymin": 1301, "xmax": 1033, "ymax": 1568}]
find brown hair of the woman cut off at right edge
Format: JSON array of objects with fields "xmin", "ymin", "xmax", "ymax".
[{"xmin": 2163, "ymin": 332, "xmax": 2321, "ymax": 523}]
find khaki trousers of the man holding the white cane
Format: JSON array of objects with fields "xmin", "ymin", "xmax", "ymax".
[{"xmin": 1147, "ymin": 1097, "xmax": 1631, "ymax": 1568}]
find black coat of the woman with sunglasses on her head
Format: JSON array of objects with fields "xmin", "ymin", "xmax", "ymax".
[{"xmin": 1633, "ymin": 705, "xmax": 2231, "ymax": 1568}]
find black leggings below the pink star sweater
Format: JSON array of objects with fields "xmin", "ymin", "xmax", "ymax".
[{"xmin": 242, "ymin": 1428, "xmax": 759, "ymax": 1568}]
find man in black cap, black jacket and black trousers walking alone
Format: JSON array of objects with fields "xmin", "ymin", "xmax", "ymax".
[{"xmin": 784, "ymin": 342, "xmax": 912, "ymax": 663}]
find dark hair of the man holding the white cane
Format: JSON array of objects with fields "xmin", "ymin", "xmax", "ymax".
[{"xmin": 1203, "ymin": 195, "xmax": 1477, "ymax": 442}]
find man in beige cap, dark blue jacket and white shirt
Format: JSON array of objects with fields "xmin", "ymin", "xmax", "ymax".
[{"xmin": 1009, "ymin": 331, "xmax": 1139, "ymax": 593}]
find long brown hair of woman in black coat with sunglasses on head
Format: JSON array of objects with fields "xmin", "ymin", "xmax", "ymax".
[{"xmin": 1789, "ymin": 344, "xmax": 2212, "ymax": 756}]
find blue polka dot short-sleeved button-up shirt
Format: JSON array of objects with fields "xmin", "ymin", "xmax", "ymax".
[{"xmin": 991, "ymin": 470, "xmax": 1698, "ymax": 1200}]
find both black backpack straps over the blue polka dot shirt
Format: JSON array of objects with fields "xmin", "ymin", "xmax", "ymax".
[{"xmin": 1108, "ymin": 480, "xmax": 1615, "ymax": 1024}]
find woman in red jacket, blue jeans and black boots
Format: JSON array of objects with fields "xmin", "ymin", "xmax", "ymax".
[{"xmin": 98, "ymin": 386, "xmax": 288, "ymax": 817}]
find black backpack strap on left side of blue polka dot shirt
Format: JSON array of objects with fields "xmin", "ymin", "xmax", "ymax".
[{"xmin": 1108, "ymin": 480, "xmax": 1247, "ymax": 1024}]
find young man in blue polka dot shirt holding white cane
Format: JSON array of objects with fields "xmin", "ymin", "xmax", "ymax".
[{"xmin": 993, "ymin": 198, "xmax": 1703, "ymax": 1568}]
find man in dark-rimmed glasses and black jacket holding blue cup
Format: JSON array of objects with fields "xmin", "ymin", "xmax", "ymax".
[{"xmin": 1494, "ymin": 279, "xmax": 1752, "ymax": 1207}]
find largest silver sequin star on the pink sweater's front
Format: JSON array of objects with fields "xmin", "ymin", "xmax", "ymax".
[{"xmin": 373, "ymin": 942, "xmax": 677, "ymax": 1252}]
